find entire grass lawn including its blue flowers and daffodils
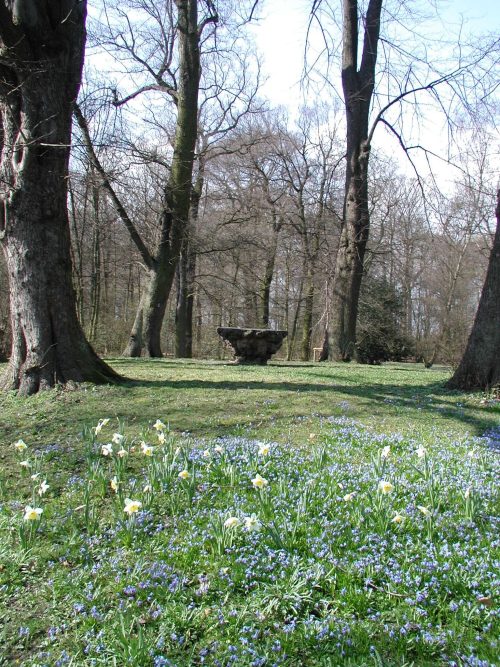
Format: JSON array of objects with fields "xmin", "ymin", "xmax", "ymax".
[{"xmin": 0, "ymin": 359, "xmax": 500, "ymax": 667}]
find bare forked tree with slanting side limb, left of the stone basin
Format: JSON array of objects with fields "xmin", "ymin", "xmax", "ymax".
[{"xmin": 75, "ymin": 0, "xmax": 258, "ymax": 356}]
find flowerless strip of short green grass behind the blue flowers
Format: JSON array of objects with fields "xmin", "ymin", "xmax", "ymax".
[{"xmin": 0, "ymin": 359, "xmax": 500, "ymax": 452}]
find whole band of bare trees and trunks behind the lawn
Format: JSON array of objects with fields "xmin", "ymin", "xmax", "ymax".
[{"xmin": 0, "ymin": 0, "xmax": 500, "ymax": 394}]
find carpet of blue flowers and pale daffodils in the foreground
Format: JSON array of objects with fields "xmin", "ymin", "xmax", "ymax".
[{"xmin": 0, "ymin": 418, "xmax": 500, "ymax": 667}]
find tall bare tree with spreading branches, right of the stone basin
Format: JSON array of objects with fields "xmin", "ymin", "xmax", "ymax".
[{"xmin": 311, "ymin": 0, "xmax": 500, "ymax": 361}]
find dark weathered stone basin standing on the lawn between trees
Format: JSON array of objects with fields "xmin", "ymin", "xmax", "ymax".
[{"xmin": 217, "ymin": 327, "xmax": 288, "ymax": 366}]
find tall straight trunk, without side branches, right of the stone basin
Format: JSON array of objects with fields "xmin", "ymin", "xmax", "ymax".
[{"xmin": 329, "ymin": 0, "xmax": 382, "ymax": 361}]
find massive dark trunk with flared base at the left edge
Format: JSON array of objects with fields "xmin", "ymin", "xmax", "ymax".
[{"xmin": 0, "ymin": 0, "xmax": 119, "ymax": 395}]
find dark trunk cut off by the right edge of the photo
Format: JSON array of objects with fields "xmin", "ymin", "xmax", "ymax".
[{"xmin": 447, "ymin": 190, "xmax": 500, "ymax": 391}]
